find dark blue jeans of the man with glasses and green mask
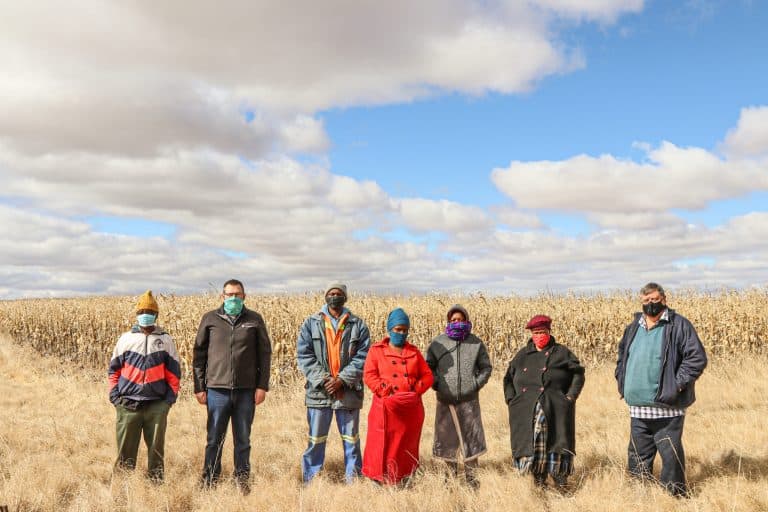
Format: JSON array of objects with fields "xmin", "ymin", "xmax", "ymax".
[{"xmin": 203, "ymin": 388, "xmax": 256, "ymax": 482}]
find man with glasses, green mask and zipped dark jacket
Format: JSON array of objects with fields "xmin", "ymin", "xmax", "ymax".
[{"xmin": 192, "ymin": 279, "xmax": 272, "ymax": 494}]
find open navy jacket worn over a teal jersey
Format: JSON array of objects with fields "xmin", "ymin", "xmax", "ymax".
[{"xmin": 615, "ymin": 309, "xmax": 707, "ymax": 409}]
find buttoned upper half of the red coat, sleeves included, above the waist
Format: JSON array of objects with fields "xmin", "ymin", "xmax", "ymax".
[{"xmin": 363, "ymin": 337, "xmax": 434, "ymax": 397}]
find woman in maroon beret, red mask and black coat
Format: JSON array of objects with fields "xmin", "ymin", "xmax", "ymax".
[{"xmin": 504, "ymin": 315, "xmax": 584, "ymax": 488}]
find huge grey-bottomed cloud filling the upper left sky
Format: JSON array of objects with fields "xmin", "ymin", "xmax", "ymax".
[{"xmin": 0, "ymin": 0, "xmax": 638, "ymax": 158}]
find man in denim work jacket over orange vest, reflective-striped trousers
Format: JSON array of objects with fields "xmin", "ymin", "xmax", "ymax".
[{"xmin": 297, "ymin": 283, "xmax": 371, "ymax": 483}]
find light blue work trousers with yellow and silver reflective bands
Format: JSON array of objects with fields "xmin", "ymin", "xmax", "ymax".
[{"xmin": 301, "ymin": 407, "xmax": 363, "ymax": 483}]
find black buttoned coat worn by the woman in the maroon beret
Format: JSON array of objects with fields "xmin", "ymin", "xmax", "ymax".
[{"xmin": 504, "ymin": 337, "xmax": 584, "ymax": 457}]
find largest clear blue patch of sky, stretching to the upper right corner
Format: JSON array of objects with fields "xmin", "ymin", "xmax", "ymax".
[{"xmin": 321, "ymin": 0, "xmax": 768, "ymax": 224}]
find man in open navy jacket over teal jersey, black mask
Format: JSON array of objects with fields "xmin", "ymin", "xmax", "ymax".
[{"xmin": 616, "ymin": 283, "xmax": 707, "ymax": 496}]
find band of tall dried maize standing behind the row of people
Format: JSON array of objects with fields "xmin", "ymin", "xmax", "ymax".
[{"xmin": 0, "ymin": 289, "xmax": 768, "ymax": 384}]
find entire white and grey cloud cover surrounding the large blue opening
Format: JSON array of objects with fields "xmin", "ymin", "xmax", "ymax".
[{"xmin": 0, "ymin": 0, "xmax": 768, "ymax": 297}]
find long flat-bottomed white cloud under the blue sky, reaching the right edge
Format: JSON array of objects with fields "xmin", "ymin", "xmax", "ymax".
[{"xmin": 491, "ymin": 142, "xmax": 768, "ymax": 213}]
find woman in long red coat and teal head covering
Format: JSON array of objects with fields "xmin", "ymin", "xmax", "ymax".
[{"xmin": 363, "ymin": 308, "xmax": 433, "ymax": 484}]
